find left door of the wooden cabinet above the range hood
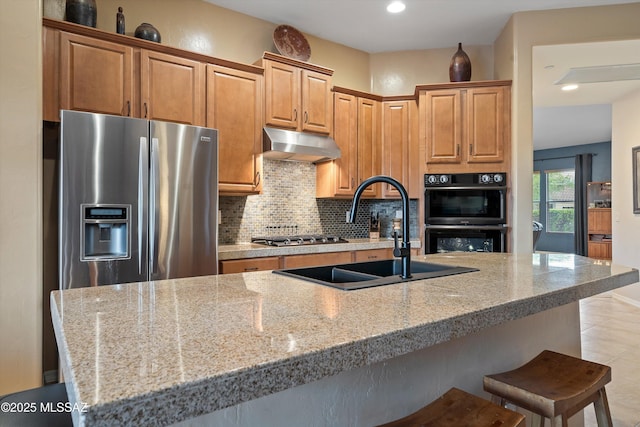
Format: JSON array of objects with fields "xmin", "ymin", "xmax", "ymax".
[{"xmin": 264, "ymin": 61, "xmax": 302, "ymax": 129}]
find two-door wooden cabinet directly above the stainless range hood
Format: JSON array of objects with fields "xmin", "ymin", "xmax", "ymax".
[{"xmin": 261, "ymin": 53, "xmax": 333, "ymax": 134}]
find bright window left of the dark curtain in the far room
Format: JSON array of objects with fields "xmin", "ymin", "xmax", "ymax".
[{"xmin": 545, "ymin": 169, "xmax": 575, "ymax": 233}]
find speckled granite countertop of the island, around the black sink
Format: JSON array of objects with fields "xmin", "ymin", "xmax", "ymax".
[{"xmin": 51, "ymin": 253, "xmax": 638, "ymax": 426}]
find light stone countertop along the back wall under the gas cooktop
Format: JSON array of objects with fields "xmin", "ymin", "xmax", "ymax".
[{"xmin": 218, "ymin": 237, "xmax": 420, "ymax": 261}]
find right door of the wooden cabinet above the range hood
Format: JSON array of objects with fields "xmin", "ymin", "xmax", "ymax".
[{"xmin": 301, "ymin": 70, "xmax": 333, "ymax": 134}]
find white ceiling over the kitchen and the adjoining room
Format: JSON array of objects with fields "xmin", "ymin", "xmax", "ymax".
[{"xmin": 205, "ymin": 0, "xmax": 640, "ymax": 149}]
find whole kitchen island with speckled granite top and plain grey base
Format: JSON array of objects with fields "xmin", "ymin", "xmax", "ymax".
[{"xmin": 51, "ymin": 253, "xmax": 638, "ymax": 426}]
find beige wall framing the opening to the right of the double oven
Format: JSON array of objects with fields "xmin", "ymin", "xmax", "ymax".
[{"xmin": 495, "ymin": 3, "xmax": 640, "ymax": 254}]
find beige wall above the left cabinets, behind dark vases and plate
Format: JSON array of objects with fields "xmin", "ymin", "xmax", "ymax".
[{"xmin": 44, "ymin": 0, "xmax": 370, "ymax": 91}]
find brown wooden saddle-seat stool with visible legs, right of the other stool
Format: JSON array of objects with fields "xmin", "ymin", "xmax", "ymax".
[{"xmin": 484, "ymin": 350, "xmax": 613, "ymax": 427}]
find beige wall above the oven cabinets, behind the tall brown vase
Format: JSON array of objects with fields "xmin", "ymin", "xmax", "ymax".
[{"xmin": 370, "ymin": 44, "xmax": 493, "ymax": 95}]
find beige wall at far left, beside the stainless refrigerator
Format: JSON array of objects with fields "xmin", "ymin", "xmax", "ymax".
[{"xmin": 0, "ymin": 0, "xmax": 42, "ymax": 395}]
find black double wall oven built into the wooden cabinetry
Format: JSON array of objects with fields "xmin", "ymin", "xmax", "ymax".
[{"xmin": 424, "ymin": 172, "xmax": 507, "ymax": 254}]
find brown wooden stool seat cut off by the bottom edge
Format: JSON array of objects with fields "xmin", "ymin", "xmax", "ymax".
[{"xmin": 380, "ymin": 388, "xmax": 525, "ymax": 427}]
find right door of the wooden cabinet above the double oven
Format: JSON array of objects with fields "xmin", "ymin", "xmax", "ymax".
[{"xmin": 464, "ymin": 87, "xmax": 506, "ymax": 163}]
